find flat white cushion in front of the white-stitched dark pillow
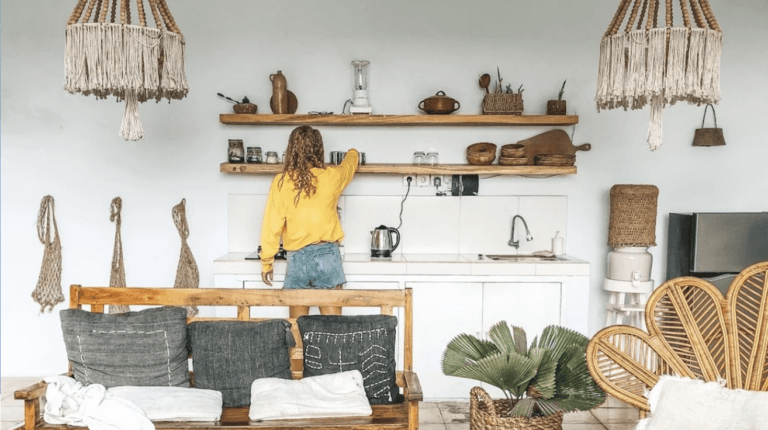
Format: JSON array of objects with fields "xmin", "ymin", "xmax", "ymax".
[{"xmin": 248, "ymin": 370, "xmax": 372, "ymax": 421}]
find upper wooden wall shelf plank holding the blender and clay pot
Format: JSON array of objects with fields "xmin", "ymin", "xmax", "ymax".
[{"xmin": 219, "ymin": 113, "xmax": 579, "ymax": 126}]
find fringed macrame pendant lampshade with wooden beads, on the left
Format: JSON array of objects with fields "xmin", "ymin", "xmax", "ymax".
[{"xmin": 64, "ymin": 0, "xmax": 189, "ymax": 140}]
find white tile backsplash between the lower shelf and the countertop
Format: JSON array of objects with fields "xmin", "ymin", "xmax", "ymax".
[{"xmin": 227, "ymin": 194, "xmax": 568, "ymax": 254}]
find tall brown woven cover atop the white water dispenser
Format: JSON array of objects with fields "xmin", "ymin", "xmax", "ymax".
[{"xmin": 608, "ymin": 185, "xmax": 659, "ymax": 248}]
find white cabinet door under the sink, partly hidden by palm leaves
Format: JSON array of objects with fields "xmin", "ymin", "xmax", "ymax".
[{"xmin": 482, "ymin": 282, "xmax": 561, "ymax": 399}]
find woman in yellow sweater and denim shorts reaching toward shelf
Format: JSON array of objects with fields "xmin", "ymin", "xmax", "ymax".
[{"xmin": 259, "ymin": 125, "xmax": 359, "ymax": 318}]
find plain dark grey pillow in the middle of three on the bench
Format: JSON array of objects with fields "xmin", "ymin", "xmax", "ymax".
[{"xmin": 189, "ymin": 319, "xmax": 296, "ymax": 407}]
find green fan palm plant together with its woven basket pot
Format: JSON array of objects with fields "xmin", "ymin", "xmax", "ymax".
[{"xmin": 442, "ymin": 321, "xmax": 605, "ymax": 430}]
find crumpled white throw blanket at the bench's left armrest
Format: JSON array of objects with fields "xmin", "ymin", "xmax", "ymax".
[{"xmin": 43, "ymin": 376, "xmax": 155, "ymax": 430}]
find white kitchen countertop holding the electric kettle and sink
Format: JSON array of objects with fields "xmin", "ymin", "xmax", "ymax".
[{"xmin": 213, "ymin": 252, "xmax": 589, "ymax": 276}]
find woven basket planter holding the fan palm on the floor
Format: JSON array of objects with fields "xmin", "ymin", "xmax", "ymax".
[{"xmin": 469, "ymin": 387, "xmax": 563, "ymax": 430}]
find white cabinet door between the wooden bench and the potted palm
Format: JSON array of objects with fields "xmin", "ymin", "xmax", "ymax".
[{"xmin": 406, "ymin": 282, "xmax": 483, "ymax": 401}]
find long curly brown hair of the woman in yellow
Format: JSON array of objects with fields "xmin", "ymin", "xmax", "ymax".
[{"xmin": 278, "ymin": 125, "xmax": 325, "ymax": 205}]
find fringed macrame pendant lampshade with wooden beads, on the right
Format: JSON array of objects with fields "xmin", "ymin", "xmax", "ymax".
[{"xmin": 595, "ymin": 0, "xmax": 723, "ymax": 150}]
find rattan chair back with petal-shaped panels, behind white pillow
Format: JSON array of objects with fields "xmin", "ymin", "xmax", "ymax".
[{"xmin": 587, "ymin": 262, "xmax": 768, "ymax": 415}]
